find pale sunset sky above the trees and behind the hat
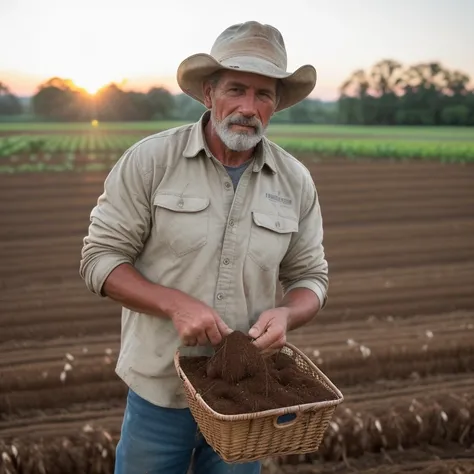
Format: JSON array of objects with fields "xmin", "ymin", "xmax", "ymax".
[{"xmin": 0, "ymin": 0, "xmax": 474, "ymax": 100}]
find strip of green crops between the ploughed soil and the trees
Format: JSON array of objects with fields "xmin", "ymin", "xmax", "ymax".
[{"xmin": 0, "ymin": 133, "xmax": 474, "ymax": 173}]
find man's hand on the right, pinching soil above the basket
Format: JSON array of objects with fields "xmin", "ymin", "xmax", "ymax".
[{"xmin": 249, "ymin": 307, "xmax": 290, "ymax": 354}]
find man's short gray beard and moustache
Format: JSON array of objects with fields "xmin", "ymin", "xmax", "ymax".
[{"xmin": 211, "ymin": 110, "xmax": 266, "ymax": 151}]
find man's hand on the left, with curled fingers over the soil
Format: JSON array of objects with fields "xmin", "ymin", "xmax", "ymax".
[{"xmin": 168, "ymin": 291, "xmax": 232, "ymax": 346}]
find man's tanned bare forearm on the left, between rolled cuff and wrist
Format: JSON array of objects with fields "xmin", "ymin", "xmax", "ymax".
[{"xmin": 102, "ymin": 263, "xmax": 175, "ymax": 318}]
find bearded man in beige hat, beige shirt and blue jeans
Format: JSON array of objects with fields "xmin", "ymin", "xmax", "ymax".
[{"xmin": 80, "ymin": 21, "xmax": 328, "ymax": 474}]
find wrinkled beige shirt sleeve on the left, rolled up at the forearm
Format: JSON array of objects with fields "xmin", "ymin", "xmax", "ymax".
[{"xmin": 79, "ymin": 147, "xmax": 150, "ymax": 296}]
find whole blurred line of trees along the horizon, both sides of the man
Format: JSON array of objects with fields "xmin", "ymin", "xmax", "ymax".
[{"xmin": 0, "ymin": 60, "xmax": 474, "ymax": 126}]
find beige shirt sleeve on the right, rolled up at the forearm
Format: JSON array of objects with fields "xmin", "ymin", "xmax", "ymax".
[{"xmin": 280, "ymin": 172, "xmax": 328, "ymax": 309}]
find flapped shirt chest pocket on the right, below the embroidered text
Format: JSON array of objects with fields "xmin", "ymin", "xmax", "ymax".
[{"xmin": 248, "ymin": 211, "xmax": 298, "ymax": 270}]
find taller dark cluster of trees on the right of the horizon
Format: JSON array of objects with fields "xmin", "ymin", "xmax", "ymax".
[{"xmin": 338, "ymin": 60, "xmax": 474, "ymax": 126}]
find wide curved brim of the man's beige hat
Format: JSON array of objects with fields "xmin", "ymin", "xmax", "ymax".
[{"xmin": 177, "ymin": 53, "xmax": 317, "ymax": 111}]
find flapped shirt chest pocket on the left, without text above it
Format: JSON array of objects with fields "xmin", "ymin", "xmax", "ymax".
[{"xmin": 153, "ymin": 193, "xmax": 210, "ymax": 257}]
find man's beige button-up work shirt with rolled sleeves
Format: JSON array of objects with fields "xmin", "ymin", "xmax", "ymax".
[{"xmin": 80, "ymin": 112, "xmax": 328, "ymax": 408}]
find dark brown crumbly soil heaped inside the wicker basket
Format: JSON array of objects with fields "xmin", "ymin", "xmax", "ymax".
[{"xmin": 180, "ymin": 331, "xmax": 336, "ymax": 415}]
